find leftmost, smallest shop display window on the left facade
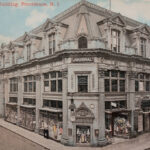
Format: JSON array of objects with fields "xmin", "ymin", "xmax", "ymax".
[{"xmin": 6, "ymin": 103, "xmax": 17, "ymax": 124}]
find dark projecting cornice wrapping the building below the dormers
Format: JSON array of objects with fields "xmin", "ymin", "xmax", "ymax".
[{"xmin": 0, "ymin": 49, "xmax": 150, "ymax": 74}]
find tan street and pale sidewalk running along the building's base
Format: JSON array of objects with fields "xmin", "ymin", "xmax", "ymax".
[{"xmin": 0, "ymin": 119, "xmax": 150, "ymax": 150}]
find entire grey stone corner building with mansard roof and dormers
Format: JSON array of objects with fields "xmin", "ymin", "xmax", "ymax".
[{"xmin": 0, "ymin": 0, "xmax": 150, "ymax": 146}]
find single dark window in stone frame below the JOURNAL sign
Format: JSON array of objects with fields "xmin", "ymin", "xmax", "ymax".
[{"xmin": 78, "ymin": 76, "xmax": 88, "ymax": 93}]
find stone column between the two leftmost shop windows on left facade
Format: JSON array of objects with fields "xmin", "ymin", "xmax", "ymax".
[{"xmin": 17, "ymin": 76, "xmax": 23, "ymax": 125}]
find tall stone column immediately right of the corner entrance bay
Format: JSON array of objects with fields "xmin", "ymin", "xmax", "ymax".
[{"xmin": 98, "ymin": 69, "xmax": 107, "ymax": 146}]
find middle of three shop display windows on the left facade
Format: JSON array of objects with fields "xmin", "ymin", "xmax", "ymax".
[{"xmin": 20, "ymin": 105, "xmax": 36, "ymax": 131}]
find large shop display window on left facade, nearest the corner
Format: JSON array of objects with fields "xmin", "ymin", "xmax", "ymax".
[{"xmin": 40, "ymin": 108, "xmax": 63, "ymax": 141}]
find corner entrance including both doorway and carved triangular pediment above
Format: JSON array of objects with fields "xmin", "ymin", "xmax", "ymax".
[{"xmin": 70, "ymin": 103, "xmax": 95, "ymax": 145}]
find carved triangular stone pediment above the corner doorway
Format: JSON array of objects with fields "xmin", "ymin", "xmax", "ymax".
[{"xmin": 75, "ymin": 103, "xmax": 95, "ymax": 123}]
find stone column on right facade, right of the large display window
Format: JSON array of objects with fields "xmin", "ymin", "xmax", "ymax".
[{"xmin": 127, "ymin": 71, "xmax": 136, "ymax": 135}]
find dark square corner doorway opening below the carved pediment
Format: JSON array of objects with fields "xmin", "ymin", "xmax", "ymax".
[{"xmin": 76, "ymin": 126, "xmax": 91, "ymax": 144}]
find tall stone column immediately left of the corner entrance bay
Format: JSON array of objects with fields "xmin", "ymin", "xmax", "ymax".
[{"xmin": 61, "ymin": 70, "xmax": 68, "ymax": 145}]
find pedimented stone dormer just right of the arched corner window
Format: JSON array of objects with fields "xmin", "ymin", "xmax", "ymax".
[{"xmin": 97, "ymin": 14, "xmax": 126, "ymax": 52}]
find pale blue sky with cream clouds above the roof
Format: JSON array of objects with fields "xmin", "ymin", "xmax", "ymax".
[{"xmin": 0, "ymin": 0, "xmax": 150, "ymax": 44}]
